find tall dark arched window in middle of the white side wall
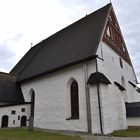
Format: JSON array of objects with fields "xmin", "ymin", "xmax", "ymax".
[{"xmin": 70, "ymin": 81, "xmax": 79, "ymax": 119}]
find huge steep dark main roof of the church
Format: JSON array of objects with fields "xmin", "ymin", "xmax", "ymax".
[{"xmin": 10, "ymin": 4, "xmax": 111, "ymax": 81}]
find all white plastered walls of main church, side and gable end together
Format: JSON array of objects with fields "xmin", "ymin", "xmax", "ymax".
[{"xmin": 21, "ymin": 42, "xmax": 139, "ymax": 134}]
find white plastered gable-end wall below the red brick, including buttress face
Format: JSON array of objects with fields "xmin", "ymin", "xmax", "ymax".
[{"xmin": 94, "ymin": 42, "xmax": 140, "ymax": 134}]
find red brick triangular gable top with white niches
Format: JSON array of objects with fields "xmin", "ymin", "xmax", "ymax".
[{"xmin": 102, "ymin": 10, "xmax": 132, "ymax": 65}]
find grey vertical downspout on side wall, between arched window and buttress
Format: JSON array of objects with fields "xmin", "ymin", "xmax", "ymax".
[{"xmin": 83, "ymin": 62, "xmax": 92, "ymax": 133}]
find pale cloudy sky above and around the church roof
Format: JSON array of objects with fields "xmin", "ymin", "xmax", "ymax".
[{"xmin": 0, "ymin": 0, "xmax": 140, "ymax": 85}]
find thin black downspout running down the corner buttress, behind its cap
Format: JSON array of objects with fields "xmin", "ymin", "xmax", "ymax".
[{"xmin": 96, "ymin": 57, "xmax": 103, "ymax": 134}]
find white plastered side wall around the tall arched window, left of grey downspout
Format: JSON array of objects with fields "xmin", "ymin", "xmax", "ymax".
[{"xmin": 21, "ymin": 64, "xmax": 91, "ymax": 132}]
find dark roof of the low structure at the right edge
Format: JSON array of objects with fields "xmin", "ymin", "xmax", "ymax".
[{"xmin": 125, "ymin": 102, "xmax": 140, "ymax": 117}]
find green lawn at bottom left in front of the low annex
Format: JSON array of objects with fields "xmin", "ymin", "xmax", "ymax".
[{"xmin": 0, "ymin": 129, "xmax": 81, "ymax": 140}]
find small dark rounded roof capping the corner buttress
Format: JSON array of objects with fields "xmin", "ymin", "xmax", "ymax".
[{"xmin": 87, "ymin": 72, "xmax": 111, "ymax": 85}]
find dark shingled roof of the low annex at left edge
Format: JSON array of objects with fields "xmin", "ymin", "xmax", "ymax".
[{"xmin": 0, "ymin": 72, "xmax": 24, "ymax": 103}]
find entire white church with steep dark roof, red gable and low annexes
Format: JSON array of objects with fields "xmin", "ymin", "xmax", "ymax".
[{"xmin": 0, "ymin": 4, "xmax": 140, "ymax": 134}]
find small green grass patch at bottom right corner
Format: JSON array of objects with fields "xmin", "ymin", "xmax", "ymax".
[{"xmin": 111, "ymin": 128, "xmax": 140, "ymax": 137}]
